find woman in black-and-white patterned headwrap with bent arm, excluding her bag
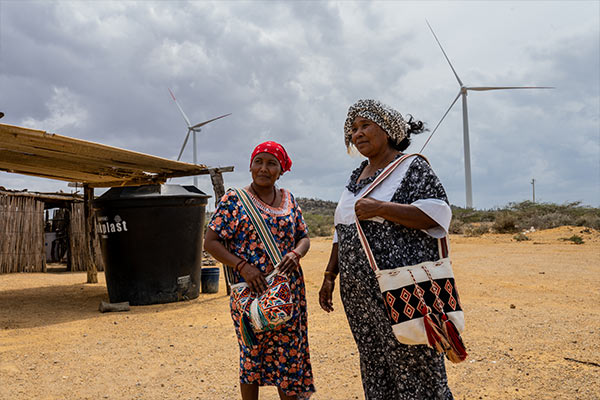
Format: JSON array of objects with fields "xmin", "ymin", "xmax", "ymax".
[{"xmin": 319, "ymin": 100, "xmax": 452, "ymax": 400}]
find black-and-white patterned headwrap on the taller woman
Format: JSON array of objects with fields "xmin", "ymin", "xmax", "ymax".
[{"xmin": 344, "ymin": 99, "xmax": 410, "ymax": 147}]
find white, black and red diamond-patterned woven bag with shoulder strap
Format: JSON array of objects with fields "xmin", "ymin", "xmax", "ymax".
[{"xmin": 355, "ymin": 154, "xmax": 467, "ymax": 363}]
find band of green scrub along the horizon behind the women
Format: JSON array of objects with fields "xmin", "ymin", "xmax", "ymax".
[{"xmin": 297, "ymin": 198, "xmax": 600, "ymax": 236}]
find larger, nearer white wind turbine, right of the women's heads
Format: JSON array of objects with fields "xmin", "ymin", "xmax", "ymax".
[{"xmin": 421, "ymin": 20, "xmax": 554, "ymax": 208}]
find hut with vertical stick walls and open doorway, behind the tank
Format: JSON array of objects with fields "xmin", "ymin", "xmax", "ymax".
[{"xmin": 0, "ymin": 190, "xmax": 104, "ymax": 274}]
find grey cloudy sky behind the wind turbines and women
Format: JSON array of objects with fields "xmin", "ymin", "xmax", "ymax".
[{"xmin": 0, "ymin": 0, "xmax": 600, "ymax": 208}]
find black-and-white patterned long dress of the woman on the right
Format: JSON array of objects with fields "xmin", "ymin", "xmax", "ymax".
[{"xmin": 336, "ymin": 158, "xmax": 453, "ymax": 400}]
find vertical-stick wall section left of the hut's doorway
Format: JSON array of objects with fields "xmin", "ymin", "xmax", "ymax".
[{"xmin": 0, "ymin": 195, "xmax": 46, "ymax": 274}]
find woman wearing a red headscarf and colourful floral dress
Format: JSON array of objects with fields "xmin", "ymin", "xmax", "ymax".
[{"xmin": 204, "ymin": 142, "xmax": 315, "ymax": 400}]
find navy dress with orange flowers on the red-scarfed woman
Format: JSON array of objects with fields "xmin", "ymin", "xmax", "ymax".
[{"xmin": 208, "ymin": 189, "xmax": 315, "ymax": 399}]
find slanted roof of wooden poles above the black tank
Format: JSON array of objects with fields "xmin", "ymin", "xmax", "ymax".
[{"xmin": 0, "ymin": 124, "xmax": 216, "ymax": 187}]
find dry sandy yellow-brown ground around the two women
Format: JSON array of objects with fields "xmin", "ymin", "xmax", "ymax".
[{"xmin": 0, "ymin": 227, "xmax": 600, "ymax": 400}]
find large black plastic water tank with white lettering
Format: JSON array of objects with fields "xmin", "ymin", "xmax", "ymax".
[{"xmin": 93, "ymin": 185, "xmax": 210, "ymax": 305}]
